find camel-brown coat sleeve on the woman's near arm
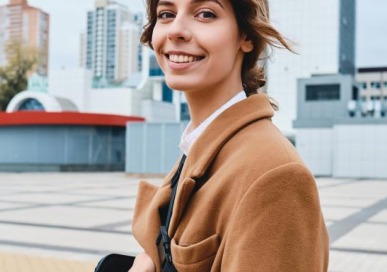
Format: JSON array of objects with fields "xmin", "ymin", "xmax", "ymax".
[{"xmin": 221, "ymin": 163, "xmax": 329, "ymax": 272}]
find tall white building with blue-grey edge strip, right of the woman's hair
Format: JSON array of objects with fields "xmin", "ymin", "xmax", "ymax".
[{"xmin": 267, "ymin": 0, "xmax": 356, "ymax": 132}]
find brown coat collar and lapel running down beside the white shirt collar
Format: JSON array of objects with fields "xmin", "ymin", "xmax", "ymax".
[{"xmin": 168, "ymin": 94, "xmax": 274, "ymax": 237}]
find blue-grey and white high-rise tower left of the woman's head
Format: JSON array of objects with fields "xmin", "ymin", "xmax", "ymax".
[{"xmin": 80, "ymin": 0, "xmax": 140, "ymax": 83}]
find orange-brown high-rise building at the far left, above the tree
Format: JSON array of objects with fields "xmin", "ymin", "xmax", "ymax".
[{"xmin": 0, "ymin": 0, "xmax": 50, "ymax": 75}]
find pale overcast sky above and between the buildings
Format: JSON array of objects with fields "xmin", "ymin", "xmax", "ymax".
[{"xmin": 0, "ymin": 0, "xmax": 387, "ymax": 69}]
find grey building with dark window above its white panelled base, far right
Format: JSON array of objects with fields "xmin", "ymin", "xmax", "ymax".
[{"xmin": 294, "ymin": 75, "xmax": 387, "ymax": 178}]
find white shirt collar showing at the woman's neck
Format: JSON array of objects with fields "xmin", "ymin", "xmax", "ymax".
[{"xmin": 179, "ymin": 91, "xmax": 246, "ymax": 156}]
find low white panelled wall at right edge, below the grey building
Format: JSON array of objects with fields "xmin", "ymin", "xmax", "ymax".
[{"xmin": 296, "ymin": 123, "xmax": 387, "ymax": 178}]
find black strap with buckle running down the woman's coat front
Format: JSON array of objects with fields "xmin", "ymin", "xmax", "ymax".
[{"xmin": 156, "ymin": 155, "xmax": 186, "ymax": 272}]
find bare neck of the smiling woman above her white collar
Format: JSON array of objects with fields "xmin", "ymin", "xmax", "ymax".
[{"xmin": 185, "ymin": 84, "xmax": 242, "ymax": 129}]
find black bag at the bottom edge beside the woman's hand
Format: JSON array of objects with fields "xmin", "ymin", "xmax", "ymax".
[{"xmin": 94, "ymin": 253, "xmax": 135, "ymax": 272}]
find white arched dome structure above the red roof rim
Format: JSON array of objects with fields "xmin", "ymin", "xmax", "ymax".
[{"xmin": 6, "ymin": 91, "xmax": 78, "ymax": 112}]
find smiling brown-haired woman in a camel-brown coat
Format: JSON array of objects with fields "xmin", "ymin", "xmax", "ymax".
[{"xmin": 130, "ymin": 0, "xmax": 329, "ymax": 272}]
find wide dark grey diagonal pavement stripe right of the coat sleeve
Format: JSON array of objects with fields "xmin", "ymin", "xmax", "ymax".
[{"xmin": 328, "ymin": 198, "xmax": 387, "ymax": 244}]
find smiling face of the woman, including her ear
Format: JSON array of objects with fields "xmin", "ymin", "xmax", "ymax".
[{"xmin": 152, "ymin": 0, "xmax": 252, "ymax": 94}]
